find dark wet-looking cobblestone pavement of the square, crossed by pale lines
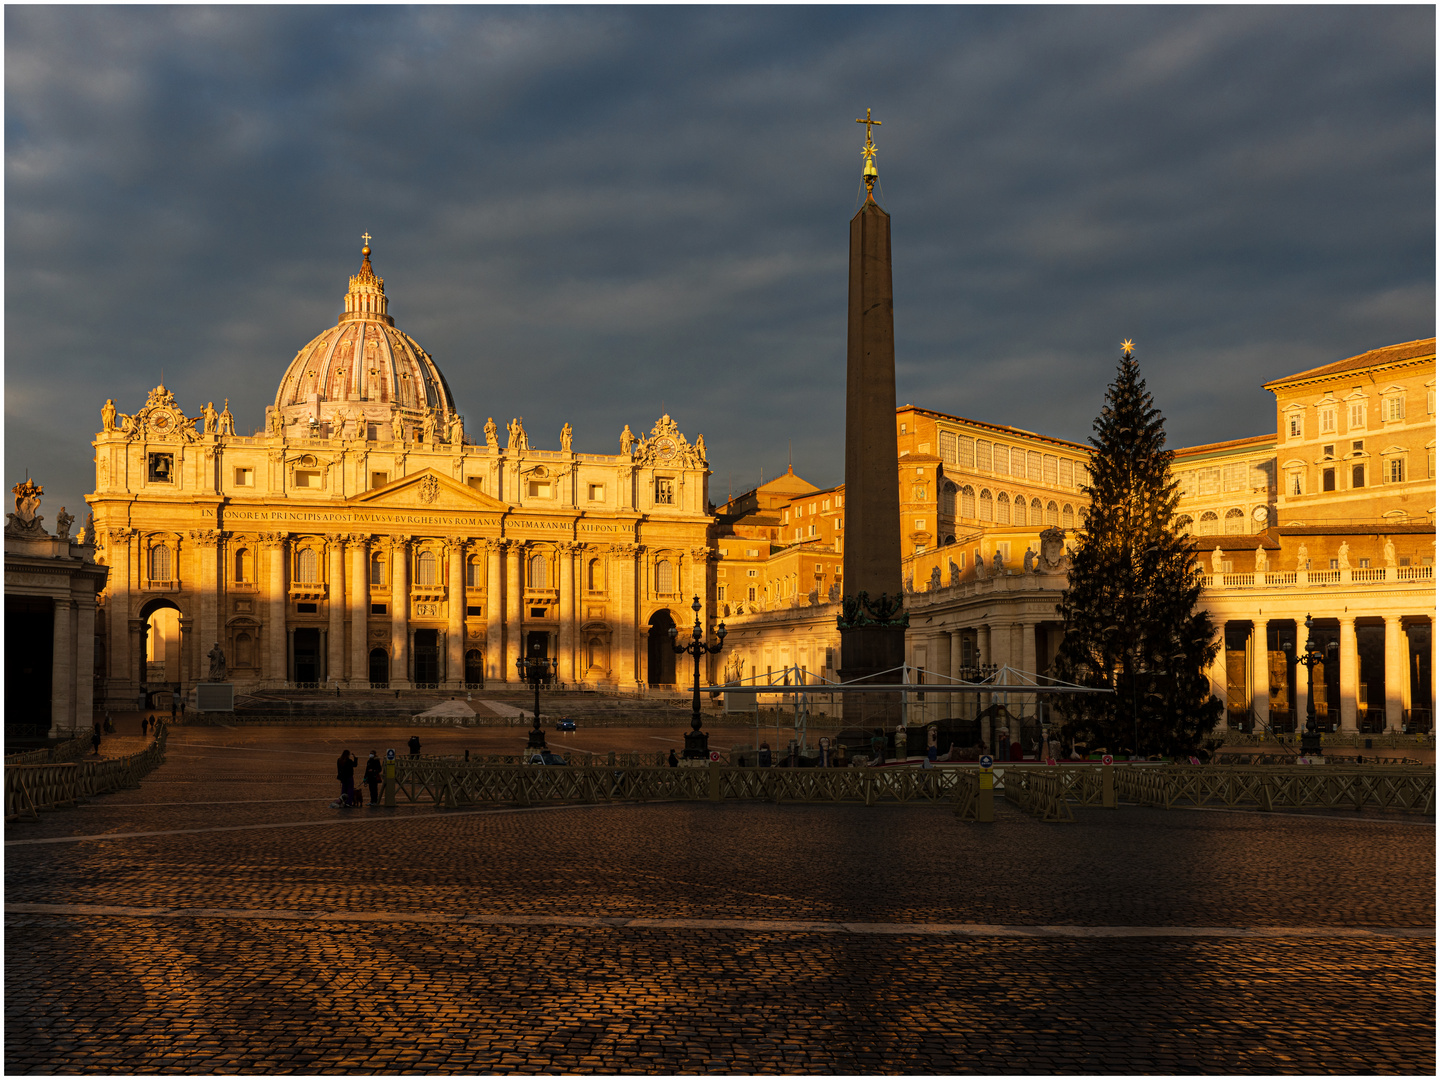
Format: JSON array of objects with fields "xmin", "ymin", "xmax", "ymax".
[{"xmin": 4, "ymin": 727, "xmax": 1436, "ymax": 1074}]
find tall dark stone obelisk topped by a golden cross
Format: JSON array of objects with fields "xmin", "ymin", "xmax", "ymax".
[{"xmin": 838, "ymin": 109, "xmax": 907, "ymax": 723}]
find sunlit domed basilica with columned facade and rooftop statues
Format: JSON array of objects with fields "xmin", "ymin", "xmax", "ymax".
[{"xmin": 89, "ymin": 238, "xmax": 711, "ymax": 703}]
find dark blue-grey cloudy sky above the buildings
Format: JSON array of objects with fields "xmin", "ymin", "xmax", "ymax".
[{"xmin": 4, "ymin": 6, "xmax": 1436, "ymax": 523}]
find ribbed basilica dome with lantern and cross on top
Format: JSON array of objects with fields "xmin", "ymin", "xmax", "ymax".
[{"xmin": 269, "ymin": 245, "xmax": 455, "ymax": 438}]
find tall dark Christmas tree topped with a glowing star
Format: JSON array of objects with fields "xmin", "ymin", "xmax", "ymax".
[{"xmin": 1056, "ymin": 341, "xmax": 1223, "ymax": 755}]
